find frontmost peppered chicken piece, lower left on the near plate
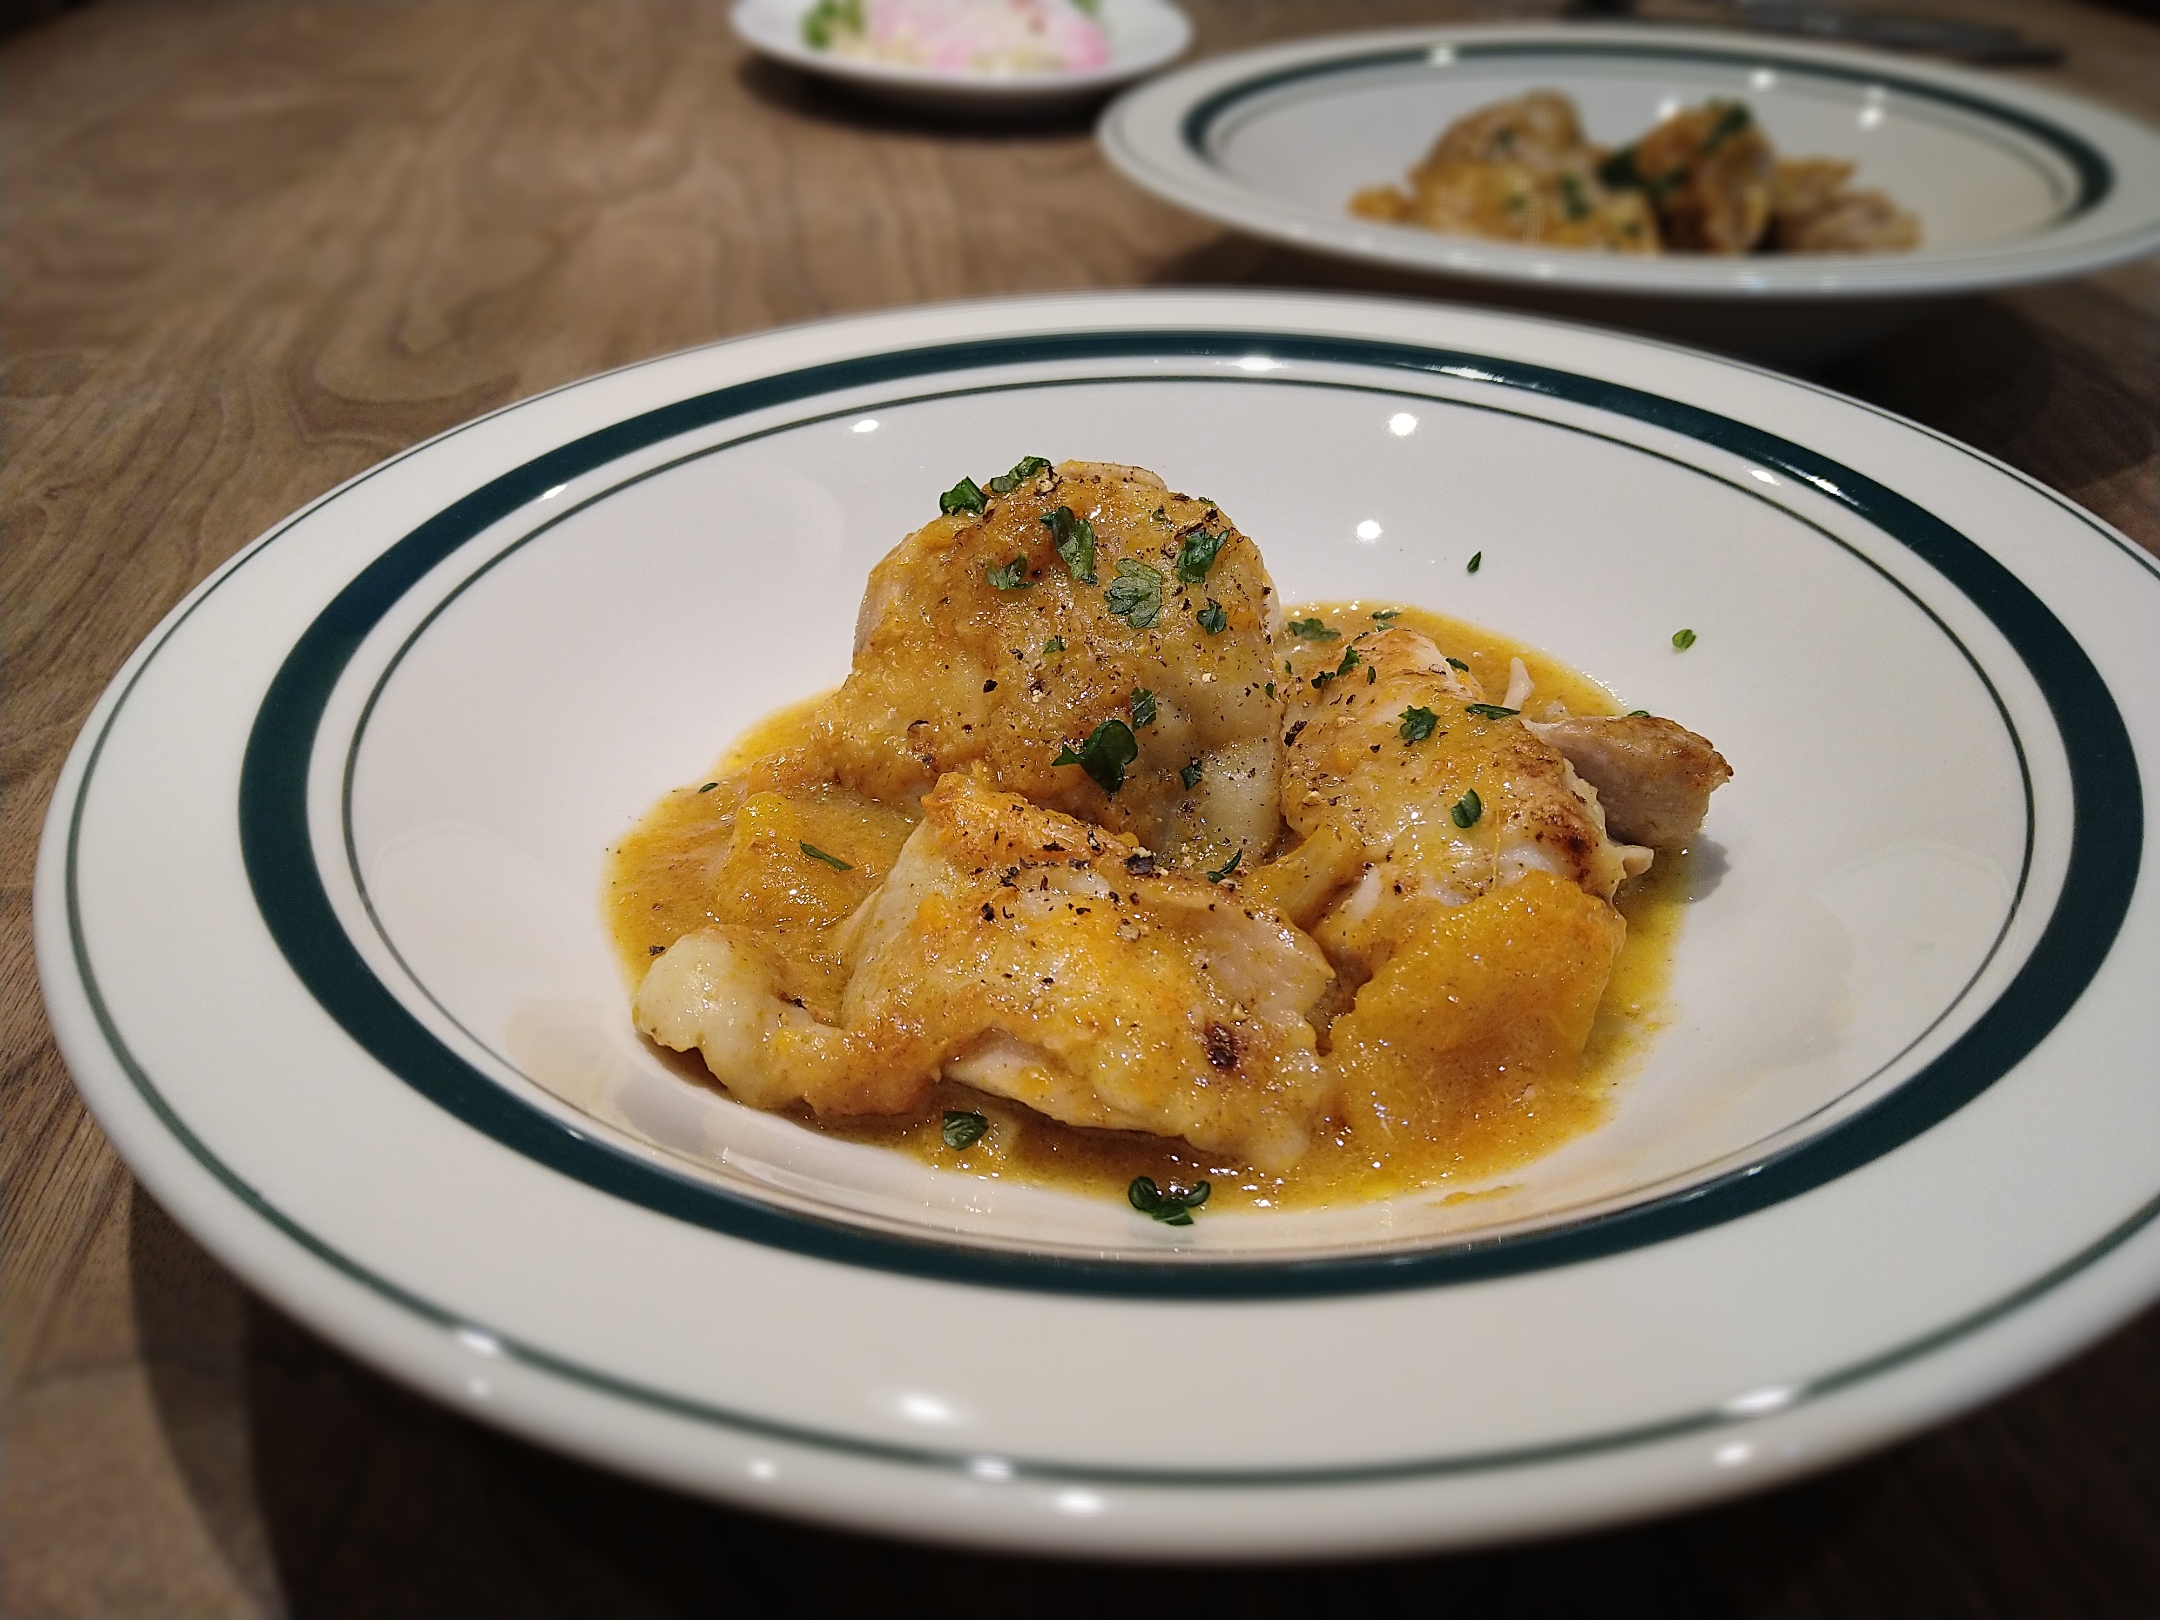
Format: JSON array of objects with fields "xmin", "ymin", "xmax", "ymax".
[{"xmin": 633, "ymin": 765, "xmax": 1333, "ymax": 1169}]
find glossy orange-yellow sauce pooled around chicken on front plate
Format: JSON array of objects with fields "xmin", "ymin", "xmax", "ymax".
[{"xmin": 605, "ymin": 603, "xmax": 1687, "ymax": 1207}]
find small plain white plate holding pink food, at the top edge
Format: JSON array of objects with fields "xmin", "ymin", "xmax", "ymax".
[{"xmin": 728, "ymin": 0, "xmax": 1192, "ymax": 112}]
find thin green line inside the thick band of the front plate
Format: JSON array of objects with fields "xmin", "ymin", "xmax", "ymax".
[{"xmin": 339, "ymin": 372, "xmax": 2037, "ymax": 1266}]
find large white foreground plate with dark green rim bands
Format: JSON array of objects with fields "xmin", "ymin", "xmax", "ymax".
[{"xmin": 37, "ymin": 294, "xmax": 2160, "ymax": 1555}]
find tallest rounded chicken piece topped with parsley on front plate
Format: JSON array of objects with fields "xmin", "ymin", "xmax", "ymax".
[{"xmin": 821, "ymin": 458, "xmax": 1281, "ymax": 870}]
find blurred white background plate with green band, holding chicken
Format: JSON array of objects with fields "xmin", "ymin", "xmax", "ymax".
[{"xmin": 1099, "ymin": 26, "xmax": 2160, "ymax": 302}]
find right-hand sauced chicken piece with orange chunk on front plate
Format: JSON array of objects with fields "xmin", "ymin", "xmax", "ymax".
[{"xmin": 1246, "ymin": 622, "xmax": 1650, "ymax": 1140}]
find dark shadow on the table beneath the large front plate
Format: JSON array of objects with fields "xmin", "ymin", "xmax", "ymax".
[{"xmin": 130, "ymin": 1188, "xmax": 2160, "ymax": 1620}]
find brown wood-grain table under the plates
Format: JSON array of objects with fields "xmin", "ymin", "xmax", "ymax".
[{"xmin": 0, "ymin": 0, "xmax": 2160, "ymax": 1618}]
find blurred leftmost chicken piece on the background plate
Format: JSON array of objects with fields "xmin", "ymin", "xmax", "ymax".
[{"xmin": 1350, "ymin": 91, "xmax": 1657, "ymax": 253}]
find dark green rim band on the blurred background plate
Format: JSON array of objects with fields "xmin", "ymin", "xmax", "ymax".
[{"xmin": 1179, "ymin": 39, "xmax": 2115, "ymax": 220}]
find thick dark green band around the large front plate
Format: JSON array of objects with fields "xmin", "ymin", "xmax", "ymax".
[{"xmin": 223, "ymin": 333, "xmax": 2143, "ymax": 1298}]
